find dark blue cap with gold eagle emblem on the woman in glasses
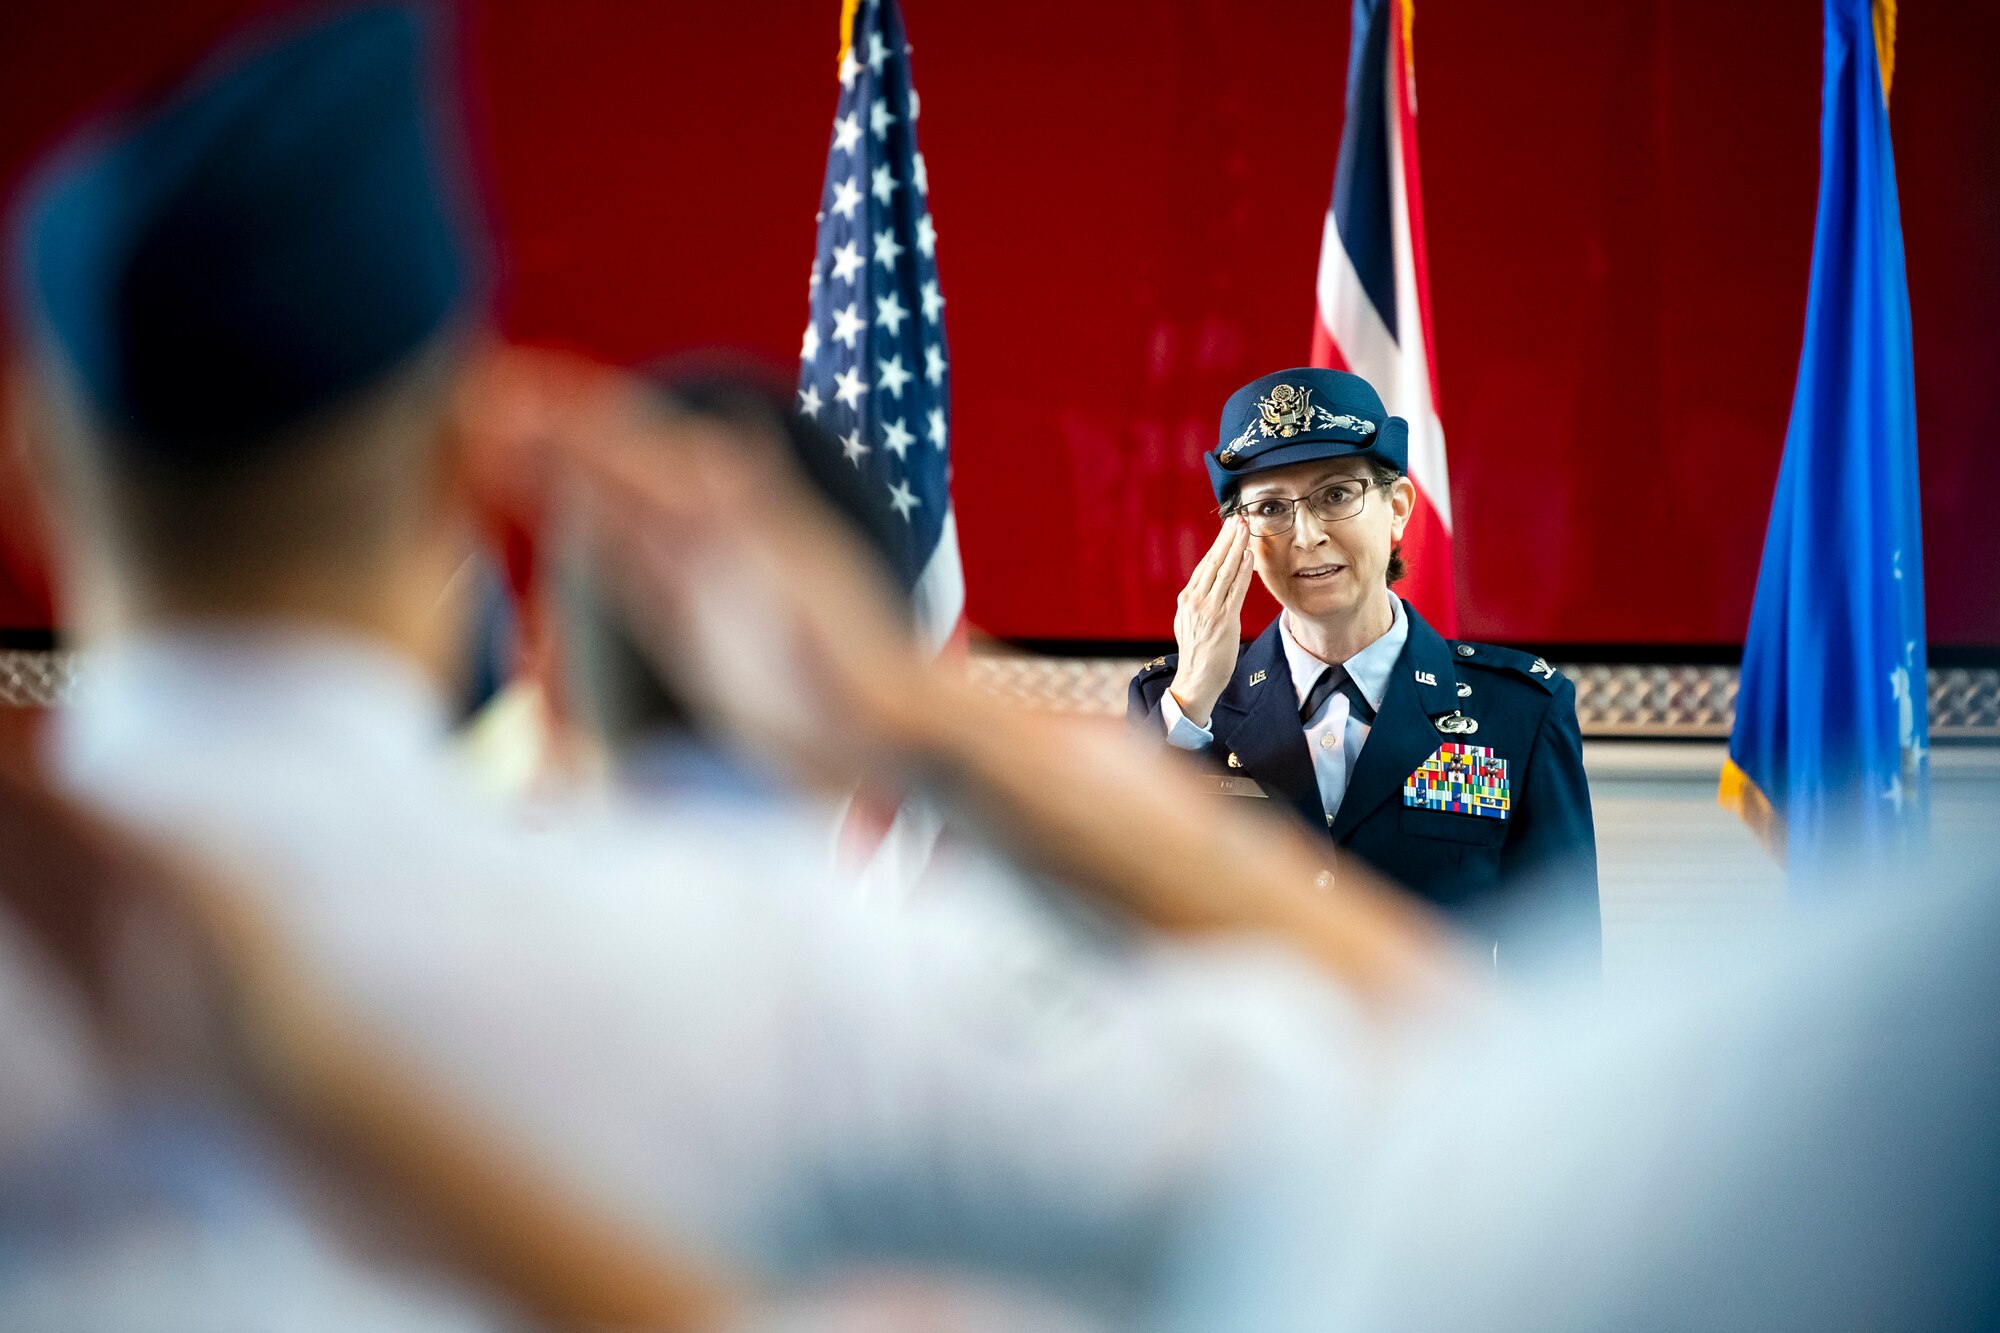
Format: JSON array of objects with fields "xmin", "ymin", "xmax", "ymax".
[{"xmin": 1202, "ymin": 366, "xmax": 1410, "ymax": 504}]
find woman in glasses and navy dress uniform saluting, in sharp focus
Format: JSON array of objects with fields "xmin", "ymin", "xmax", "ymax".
[{"xmin": 1126, "ymin": 370, "xmax": 1598, "ymax": 960}]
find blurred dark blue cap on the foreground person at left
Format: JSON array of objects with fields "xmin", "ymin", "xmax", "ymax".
[{"xmin": 14, "ymin": 6, "xmax": 480, "ymax": 466}]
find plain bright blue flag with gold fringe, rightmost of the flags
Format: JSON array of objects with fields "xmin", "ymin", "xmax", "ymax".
[{"xmin": 1722, "ymin": 0, "xmax": 1928, "ymax": 889}]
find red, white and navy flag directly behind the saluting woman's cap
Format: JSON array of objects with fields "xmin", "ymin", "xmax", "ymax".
[{"xmin": 1312, "ymin": 0, "xmax": 1458, "ymax": 634}]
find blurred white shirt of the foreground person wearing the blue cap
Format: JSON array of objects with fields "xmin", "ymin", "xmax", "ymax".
[{"xmin": 56, "ymin": 630, "xmax": 1362, "ymax": 1327}]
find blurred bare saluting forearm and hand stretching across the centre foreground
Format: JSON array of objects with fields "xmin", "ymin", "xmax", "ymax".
[{"xmin": 550, "ymin": 378, "xmax": 1478, "ymax": 1007}]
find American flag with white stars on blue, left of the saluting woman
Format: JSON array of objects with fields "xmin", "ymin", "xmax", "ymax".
[{"xmin": 798, "ymin": 0, "xmax": 966, "ymax": 650}]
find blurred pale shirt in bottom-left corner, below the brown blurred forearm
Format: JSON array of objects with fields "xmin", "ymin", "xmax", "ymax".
[{"xmin": 0, "ymin": 892, "xmax": 508, "ymax": 1333}]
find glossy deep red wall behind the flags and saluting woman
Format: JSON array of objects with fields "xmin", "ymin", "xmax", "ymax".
[{"xmin": 0, "ymin": 0, "xmax": 2000, "ymax": 644}]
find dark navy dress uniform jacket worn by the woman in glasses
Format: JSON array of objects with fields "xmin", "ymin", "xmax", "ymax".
[{"xmin": 1126, "ymin": 602, "xmax": 1598, "ymax": 949}]
